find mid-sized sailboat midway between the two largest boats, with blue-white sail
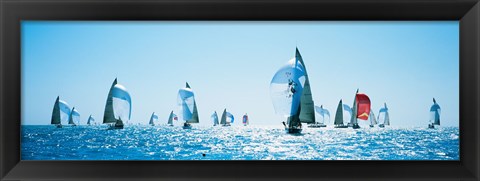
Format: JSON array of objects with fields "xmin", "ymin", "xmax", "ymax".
[{"xmin": 178, "ymin": 82, "xmax": 199, "ymax": 129}]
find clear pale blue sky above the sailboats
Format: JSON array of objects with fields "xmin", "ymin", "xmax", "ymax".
[{"xmin": 21, "ymin": 21, "xmax": 459, "ymax": 127}]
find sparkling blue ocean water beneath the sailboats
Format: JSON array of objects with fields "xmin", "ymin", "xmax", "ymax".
[{"xmin": 21, "ymin": 125, "xmax": 459, "ymax": 160}]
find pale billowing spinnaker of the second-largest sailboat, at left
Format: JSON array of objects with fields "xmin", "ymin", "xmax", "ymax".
[{"xmin": 111, "ymin": 84, "xmax": 132, "ymax": 122}]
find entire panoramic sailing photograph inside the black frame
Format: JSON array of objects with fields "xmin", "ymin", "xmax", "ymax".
[{"xmin": 20, "ymin": 21, "xmax": 460, "ymax": 161}]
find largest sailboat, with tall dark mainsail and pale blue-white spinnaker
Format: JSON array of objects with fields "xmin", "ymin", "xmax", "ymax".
[{"xmin": 270, "ymin": 48, "xmax": 315, "ymax": 133}]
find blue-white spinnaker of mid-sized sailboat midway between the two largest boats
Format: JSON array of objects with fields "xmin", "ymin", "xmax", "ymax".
[{"xmin": 178, "ymin": 88, "xmax": 195, "ymax": 121}]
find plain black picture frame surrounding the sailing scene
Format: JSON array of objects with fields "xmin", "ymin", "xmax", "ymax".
[{"xmin": 0, "ymin": 0, "xmax": 480, "ymax": 181}]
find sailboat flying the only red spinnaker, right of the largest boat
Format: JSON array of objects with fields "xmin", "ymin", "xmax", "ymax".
[{"xmin": 350, "ymin": 89, "xmax": 370, "ymax": 129}]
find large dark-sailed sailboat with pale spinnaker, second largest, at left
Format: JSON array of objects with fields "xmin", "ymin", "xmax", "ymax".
[{"xmin": 103, "ymin": 78, "xmax": 132, "ymax": 129}]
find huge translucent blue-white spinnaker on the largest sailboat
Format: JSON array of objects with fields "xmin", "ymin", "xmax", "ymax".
[{"xmin": 270, "ymin": 58, "xmax": 305, "ymax": 117}]
